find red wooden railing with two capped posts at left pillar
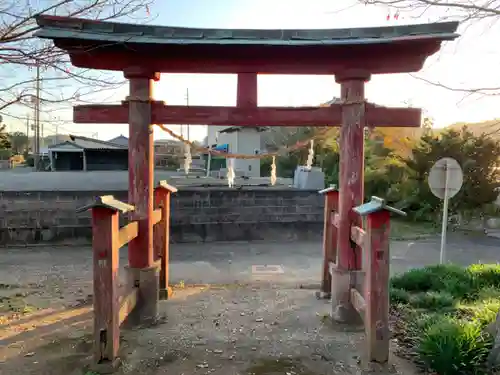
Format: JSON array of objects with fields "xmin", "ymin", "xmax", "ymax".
[{"xmin": 78, "ymin": 181, "xmax": 177, "ymax": 371}]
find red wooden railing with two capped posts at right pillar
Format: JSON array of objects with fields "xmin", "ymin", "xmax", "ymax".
[{"xmin": 320, "ymin": 187, "xmax": 406, "ymax": 363}]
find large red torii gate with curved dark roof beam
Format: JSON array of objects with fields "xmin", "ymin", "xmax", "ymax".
[{"xmin": 37, "ymin": 15, "xmax": 458, "ymax": 368}]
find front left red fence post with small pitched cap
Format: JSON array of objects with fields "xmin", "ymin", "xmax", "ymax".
[{"xmin": 78, "ymin": 195, "xmax": 133, "ymax": 370}]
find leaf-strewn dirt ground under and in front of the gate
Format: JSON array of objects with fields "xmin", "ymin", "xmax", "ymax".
[{"xmin": 0, "ymin": 282, "xmax": 416, "ymax": 375}]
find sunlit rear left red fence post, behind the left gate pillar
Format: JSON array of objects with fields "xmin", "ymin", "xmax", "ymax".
[{"xmin": 153, "ymin": 181, "xmax": 177, "ymax": 299}]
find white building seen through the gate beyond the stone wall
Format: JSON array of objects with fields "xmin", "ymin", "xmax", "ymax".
[{"xmin": 207, "ymin": 126, "xmax": 267, "ymax": 177}]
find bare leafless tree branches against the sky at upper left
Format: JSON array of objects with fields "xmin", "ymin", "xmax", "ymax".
[{"xmin": 0, "ymin": 0, "xmax": 150, "ymax": 117}]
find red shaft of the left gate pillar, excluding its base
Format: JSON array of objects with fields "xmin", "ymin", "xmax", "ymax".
[{"xmin": 124, "ymin": 68, "xmax": 160, "ymax": 269}]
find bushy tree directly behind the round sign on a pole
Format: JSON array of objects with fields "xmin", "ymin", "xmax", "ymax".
[{"xmin": 392, "ymin": 127, "xmax": 500, "ymax": 217}]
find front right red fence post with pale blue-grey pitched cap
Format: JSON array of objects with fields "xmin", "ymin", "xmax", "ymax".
[{"xmin": 354, "ymin": 197, "xmax": 406, "ymax": 363}]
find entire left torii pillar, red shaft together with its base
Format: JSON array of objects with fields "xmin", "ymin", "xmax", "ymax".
[{"xmin": 124, "ymin": 68, "xmax": 160, "ymax": 321}]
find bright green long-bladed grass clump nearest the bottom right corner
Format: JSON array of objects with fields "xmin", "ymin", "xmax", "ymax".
[{"xmin": 417, "ymin": 318, "xmax": 493, "ymax": 375}]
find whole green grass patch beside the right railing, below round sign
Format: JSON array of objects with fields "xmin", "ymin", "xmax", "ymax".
[{"xmin": 390, "ymin": 264, "xmax": 500, "ymax": 375}]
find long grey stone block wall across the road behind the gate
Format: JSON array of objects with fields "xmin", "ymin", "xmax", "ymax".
[{"xmin": 0, "ymin": 187, "xmax": 323, "ymax": 246}]
